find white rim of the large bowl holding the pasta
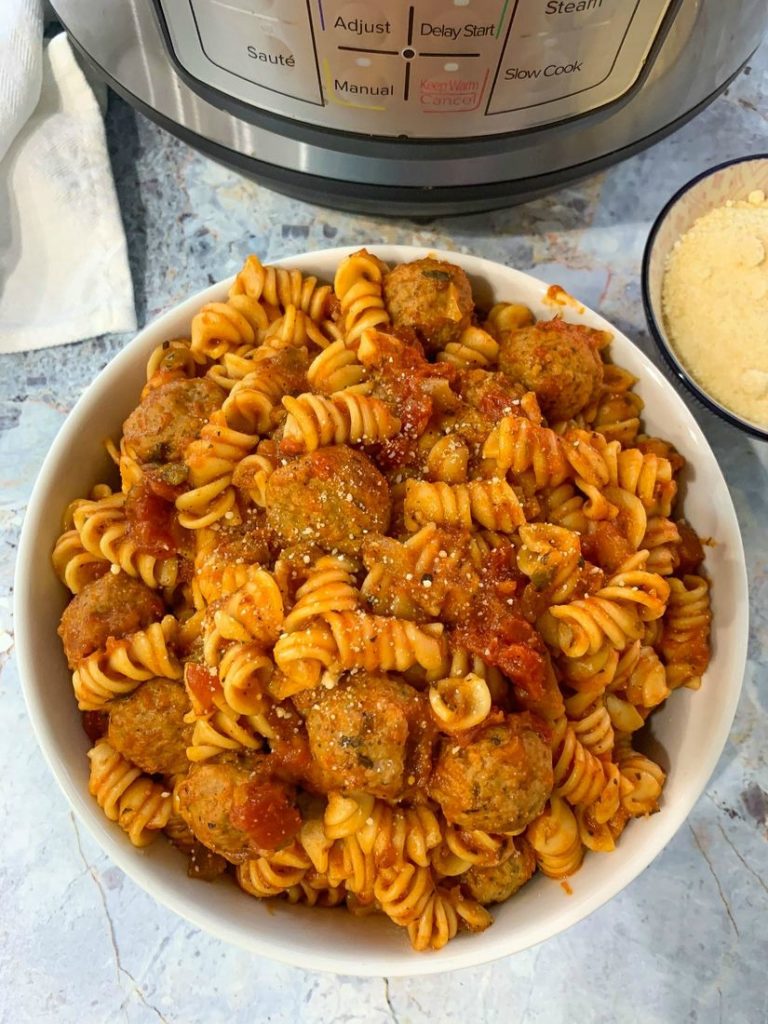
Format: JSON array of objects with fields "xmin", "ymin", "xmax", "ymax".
[{"xmin": 13, "ymin": 243, "xmax": 749, "ymax": 977}]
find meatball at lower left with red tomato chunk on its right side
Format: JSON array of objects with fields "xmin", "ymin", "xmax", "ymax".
[{"xmin": 176, "ymin": 764, "xmax": 301, "ymax": 864}]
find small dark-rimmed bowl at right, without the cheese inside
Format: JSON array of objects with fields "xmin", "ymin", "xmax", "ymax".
[{"xmin": 641, "ymin": 154, "xmax": 768, "ymax": 440}]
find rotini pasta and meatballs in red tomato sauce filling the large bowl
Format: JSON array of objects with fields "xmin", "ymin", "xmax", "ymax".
[{"xmin": 53, "ymin": 250, "xmax": 711, "ymax": 950}]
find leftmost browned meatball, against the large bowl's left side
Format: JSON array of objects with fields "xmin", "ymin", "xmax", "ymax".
[{"xmin": 58, "ymin": 572, "xmax": 165, "ymax": 669}]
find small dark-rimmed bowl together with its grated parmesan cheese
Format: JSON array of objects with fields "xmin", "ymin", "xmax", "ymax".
[{"xmin": 643, "ymin": 157, "xmax": 768, "ymax": 437}]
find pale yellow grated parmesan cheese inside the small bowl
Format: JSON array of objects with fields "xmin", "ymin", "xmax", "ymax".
[{"xmin": 662, "ymin": 190, "xmax": 768, "ymax": 426}]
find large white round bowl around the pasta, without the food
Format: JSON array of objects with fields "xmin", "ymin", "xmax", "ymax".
[{"xmin": 15, "ymin": 246, "xmax": 748, "ymax": 976}]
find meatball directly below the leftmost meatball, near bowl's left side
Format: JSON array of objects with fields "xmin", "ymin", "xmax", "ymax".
[{"xmin": 109, "ymin": 679, "xmax": 191, "ymax": 775}]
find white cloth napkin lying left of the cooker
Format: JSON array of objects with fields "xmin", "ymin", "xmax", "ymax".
[{"xmin": 0, "ymin": 12, "xmax": 136, "ymax": 352}]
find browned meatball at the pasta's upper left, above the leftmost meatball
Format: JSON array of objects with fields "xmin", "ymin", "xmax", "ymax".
[{"xmin": 123, "ymin": 377, "xmax": 226, "ymax": 463}]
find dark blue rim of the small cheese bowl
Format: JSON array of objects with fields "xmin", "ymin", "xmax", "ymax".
[{"xmin": 640, "ymin": 153, "xmax": 768, "ymax": 440}]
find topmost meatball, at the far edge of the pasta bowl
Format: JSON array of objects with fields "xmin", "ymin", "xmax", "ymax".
[{"xmin": 384, "ymin": 258, "xmax": 474, "ymax": 352}]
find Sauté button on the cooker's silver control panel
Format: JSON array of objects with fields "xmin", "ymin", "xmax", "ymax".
[{"xmin": 190, "ymin": 0, "xmax": 322, "ymax": 102}]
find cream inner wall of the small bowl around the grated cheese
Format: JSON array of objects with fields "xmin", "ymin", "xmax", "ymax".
[{"xmin": 646, "ymin": 157, "xmax": 768, "ymax": 432}]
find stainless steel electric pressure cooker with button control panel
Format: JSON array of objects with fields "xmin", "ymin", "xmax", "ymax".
[{"xmin": 54, "ymin": 0, "xmax": 768, "ymax": 215}]
